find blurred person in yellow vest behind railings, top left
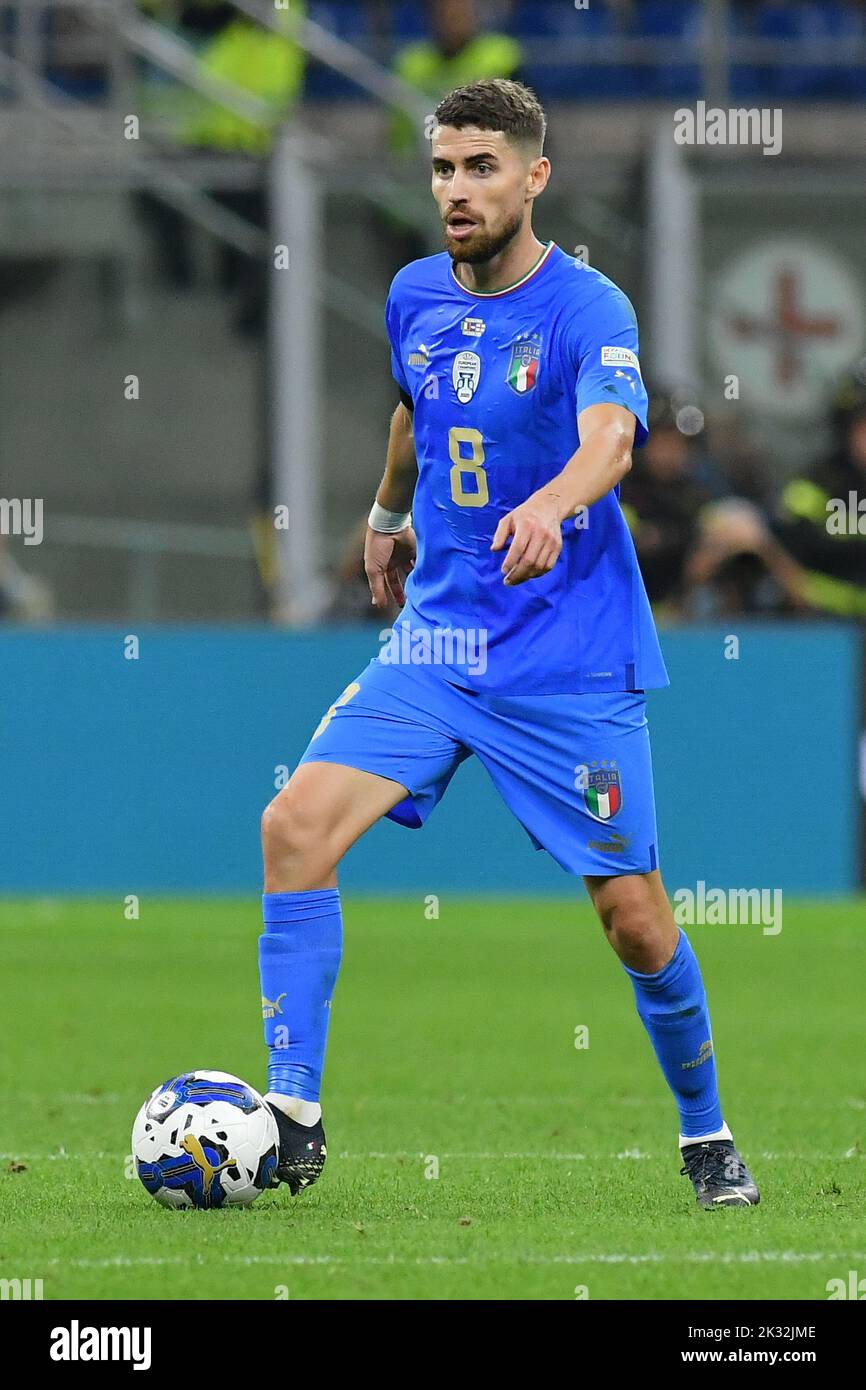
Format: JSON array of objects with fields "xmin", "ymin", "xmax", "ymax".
[{"xmin": 140, "ymin": 0, "xmax": 306, "ymax": 336}]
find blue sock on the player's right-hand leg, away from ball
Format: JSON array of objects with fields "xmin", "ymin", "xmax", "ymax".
[{"xmin": 623, "ymin": 931, "xmax": 723, "ymax": 1138}]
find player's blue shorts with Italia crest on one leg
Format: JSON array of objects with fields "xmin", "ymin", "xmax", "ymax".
[{"xmin": 302, "ymin": 657, "xmax": 657, "ymax": 876}]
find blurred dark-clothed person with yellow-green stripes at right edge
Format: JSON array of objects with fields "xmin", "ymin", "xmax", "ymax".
[{"xmin": 773, "ymin": 371, "xmax": 866, "ymax": 619}]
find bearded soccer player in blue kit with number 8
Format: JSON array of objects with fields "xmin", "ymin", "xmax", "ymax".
[{"xmin": 260, "ymin": 79, "xmax": 759, "ymax": 1207}]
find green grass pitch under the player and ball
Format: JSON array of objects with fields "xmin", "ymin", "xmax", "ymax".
[{"xmin": 0, "ymin": 895, "xmax": 866, "ymax": 1300}]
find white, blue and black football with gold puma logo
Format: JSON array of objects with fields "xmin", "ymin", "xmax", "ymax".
[{"xmin": 132, "ymin": 1072, "xmax": 278, "ymax": 1209}]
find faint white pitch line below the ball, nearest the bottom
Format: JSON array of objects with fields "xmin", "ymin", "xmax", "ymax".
[{"xmin": 47, "ymin": 1250, "xmax": 866, "ymax": 1269}]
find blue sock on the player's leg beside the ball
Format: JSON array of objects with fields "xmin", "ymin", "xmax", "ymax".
[{"xmin": 259, "ymin": 888, "xmax": 343, "ymax": 1101}]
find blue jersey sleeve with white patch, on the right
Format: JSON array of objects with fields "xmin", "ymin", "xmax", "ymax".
[{"xmin": 571, "ymin": 285, "xmax": 649, "ymax": 448}]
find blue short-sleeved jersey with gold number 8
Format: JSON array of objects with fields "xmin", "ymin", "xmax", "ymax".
[{"xmin": 384, "ymin": 242, "xmax": 667, "ymax": 695}]
